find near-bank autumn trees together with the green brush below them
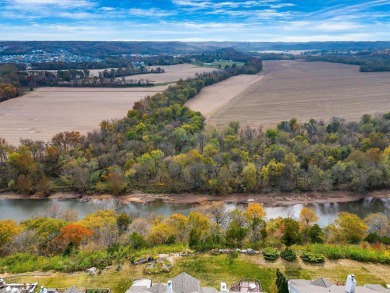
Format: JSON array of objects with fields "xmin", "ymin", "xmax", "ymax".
[{"xmin": 0, "ymin": 202, "xmax": 390, "ymax": 273}]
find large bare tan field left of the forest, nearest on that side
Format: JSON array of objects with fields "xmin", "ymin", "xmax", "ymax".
[{"xmin": 0, "ymin": 86, "xmax": 166, "ymax": 145}]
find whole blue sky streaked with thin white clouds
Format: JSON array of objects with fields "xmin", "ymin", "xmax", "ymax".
[{"xmin": 0, "ymin": 0, "xmax": 390, "ymax": 42}]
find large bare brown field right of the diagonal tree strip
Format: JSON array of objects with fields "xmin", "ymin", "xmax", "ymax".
[{"xmin": 187, "ymin": 61, "xmax": 390, "ymax": 127}]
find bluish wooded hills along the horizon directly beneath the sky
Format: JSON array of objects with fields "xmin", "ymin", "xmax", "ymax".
[{"xmin": 0, "ymin": 41, "xmax": 390, "ymax": 57}]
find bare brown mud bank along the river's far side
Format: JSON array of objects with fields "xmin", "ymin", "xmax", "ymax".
[{"xmin": 0, "ymin": 190, "xmax": 390, "ymax": 207}]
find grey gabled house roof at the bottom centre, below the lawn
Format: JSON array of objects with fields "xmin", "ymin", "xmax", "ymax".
[{"xmin": 126, "ymin": 273, "xmax": 218, "ymax": 293}]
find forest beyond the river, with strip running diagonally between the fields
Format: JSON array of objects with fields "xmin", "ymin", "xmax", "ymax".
[{"xmin": 0, "ymin": 58, "xmax": 390, "ymax": 195}]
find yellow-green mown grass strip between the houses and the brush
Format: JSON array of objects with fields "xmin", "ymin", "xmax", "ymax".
[{"xmin": 0, "ymin": 254, "xmax": 390, "ymax": 293}]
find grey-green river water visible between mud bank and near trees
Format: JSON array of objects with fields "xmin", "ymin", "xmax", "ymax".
[{"xmin": 0, "ymin": 198, "xmax": 390, "ymax": 226}]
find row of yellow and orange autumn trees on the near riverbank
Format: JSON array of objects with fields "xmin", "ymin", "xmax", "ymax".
[{"xmin": 0, "ymin": 202, "xmax": 390, "ymax": 261}]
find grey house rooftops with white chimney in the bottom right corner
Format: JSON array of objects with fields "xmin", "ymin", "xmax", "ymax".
[{"xmin": 288, "ymin": 274, "xmax": 390, "ymax": 293}]
